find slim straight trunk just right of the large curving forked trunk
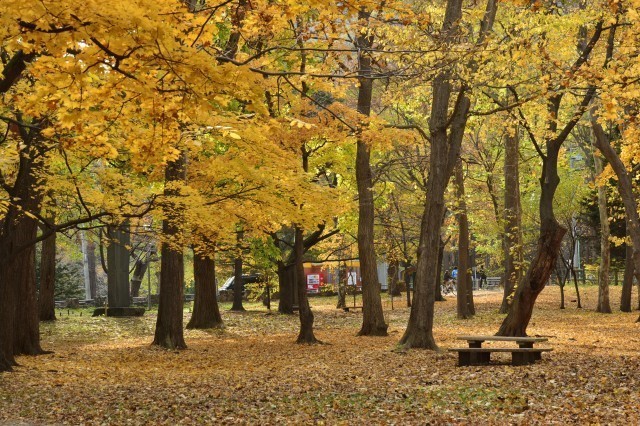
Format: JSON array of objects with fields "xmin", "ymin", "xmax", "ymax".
[{"xmin": 455, "ymin": 160, "xmax": 475, "ymax": 319}]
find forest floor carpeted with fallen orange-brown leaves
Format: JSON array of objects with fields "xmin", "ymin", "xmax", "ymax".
[{"xmin": 0, "ymin": 287, "xmax": 640, "ymax": 425}]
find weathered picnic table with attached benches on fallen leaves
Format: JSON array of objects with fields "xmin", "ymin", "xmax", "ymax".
[{"xmin": 449, "ymin": 336, "xmax": 553, "ymax": 366}]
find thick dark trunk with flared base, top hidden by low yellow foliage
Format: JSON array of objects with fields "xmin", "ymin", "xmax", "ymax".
[{"xmin": 187, "ymin": 251, "xmax": 223, "ymax": 329}]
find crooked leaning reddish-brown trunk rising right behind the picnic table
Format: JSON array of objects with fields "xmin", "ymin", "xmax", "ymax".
[{"xmin": 497, "ymin": 146, "xmax": 567, "ymax": 336}]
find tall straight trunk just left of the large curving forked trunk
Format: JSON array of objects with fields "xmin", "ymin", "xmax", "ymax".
[{"xmin": 356, "ymin": 9, "xmax": 388, "ymax": 336}]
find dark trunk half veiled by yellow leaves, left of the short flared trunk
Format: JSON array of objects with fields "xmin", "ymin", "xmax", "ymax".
[{"xmin": 153, "ymin": 151, "xmax": 187, "ymax": 349}]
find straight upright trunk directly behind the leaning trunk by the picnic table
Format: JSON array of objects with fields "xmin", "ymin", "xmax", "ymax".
[{"xmin": 500, "ymin": 128, "xmax": 523, "ymax": 314}]
